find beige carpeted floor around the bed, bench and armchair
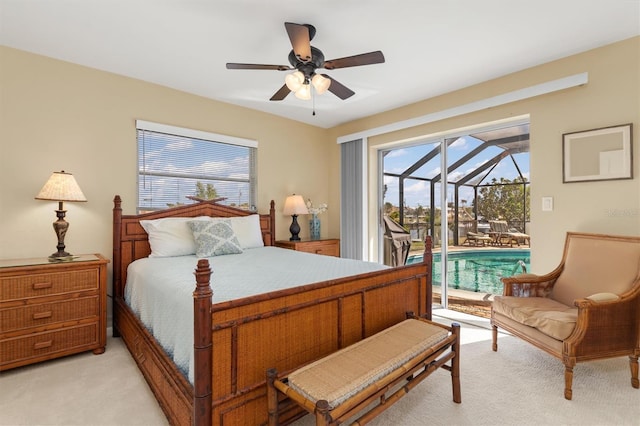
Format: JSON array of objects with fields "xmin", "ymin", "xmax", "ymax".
[{"xmin": 0, "ymin": 310, "xmax": 640, "ymax": 426}]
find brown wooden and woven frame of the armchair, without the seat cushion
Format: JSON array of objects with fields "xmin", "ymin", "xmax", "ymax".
[{"xmin": 491, "ymin": 232, "xmax": 640, "ymax": 400}]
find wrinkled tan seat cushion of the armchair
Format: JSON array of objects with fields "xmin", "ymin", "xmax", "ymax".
[{"xmin": 493, "ymin": 296, "xmax": 578, "ymax": 340}]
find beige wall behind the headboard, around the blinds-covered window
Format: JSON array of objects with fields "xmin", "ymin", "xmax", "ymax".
[{"xmin": 0, "ymin": 47, "xmax": 337, "ymax": 266}]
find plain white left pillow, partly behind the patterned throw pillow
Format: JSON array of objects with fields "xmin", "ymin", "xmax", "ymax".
[{"xmin": 140, "ymin": 216, "xmax": 210, "ymax": 257}]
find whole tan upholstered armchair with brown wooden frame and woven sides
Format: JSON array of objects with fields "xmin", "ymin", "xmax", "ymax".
[{"xmin": 491, "ymin": 232, "xmax": 640, "ymax": 399}]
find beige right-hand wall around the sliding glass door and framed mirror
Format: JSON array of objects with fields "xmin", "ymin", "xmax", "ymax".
[{"xmin": 331, "ymin": 37, "xmax": 640, "ymax": 272}]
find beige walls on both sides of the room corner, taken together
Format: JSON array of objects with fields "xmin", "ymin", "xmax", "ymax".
[{"xmin": 0, "ymin": 37, "xmax": 640, "ymax": 272}]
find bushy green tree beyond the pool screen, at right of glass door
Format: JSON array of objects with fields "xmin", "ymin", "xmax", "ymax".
[{"xmin": 476, "ymin": 177, "xmax": 530, "ymax": 226}]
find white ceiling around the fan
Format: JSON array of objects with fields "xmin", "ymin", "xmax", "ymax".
[{"xmin": 0, "ymin": 0, "xmax": 640, "ymax": 127}]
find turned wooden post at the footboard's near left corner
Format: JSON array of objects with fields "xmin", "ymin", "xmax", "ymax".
[{"xmin": 192, "ymin": 259, "xmax": 213, "ymax": 426}]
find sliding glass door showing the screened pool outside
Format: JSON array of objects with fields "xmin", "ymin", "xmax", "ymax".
[{"xmin": 379, "ymin": 123, "xmax": 530, "ymax": 307}]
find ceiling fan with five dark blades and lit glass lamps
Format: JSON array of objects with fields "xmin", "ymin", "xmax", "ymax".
[{"xmin": 227, "ymin": 22, "xmax": 384, "ymax": 101}]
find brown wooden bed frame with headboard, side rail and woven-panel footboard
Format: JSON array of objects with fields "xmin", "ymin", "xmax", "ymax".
[{"xmin": 113, "ymin": 195, "xmax": 432, "ymax": 425}]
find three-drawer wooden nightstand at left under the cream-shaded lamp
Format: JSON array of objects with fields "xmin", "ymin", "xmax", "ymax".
[{"xmin": 0, "ymin": 254, "xmax": 109, "ymax": 371}]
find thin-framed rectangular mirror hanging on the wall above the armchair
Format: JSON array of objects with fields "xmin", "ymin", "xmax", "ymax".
[{"xmin": 562, "ymin": 124, "xmax": 633, "ymax": 183}]
